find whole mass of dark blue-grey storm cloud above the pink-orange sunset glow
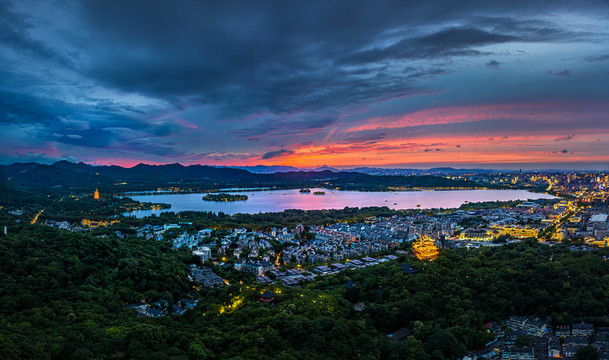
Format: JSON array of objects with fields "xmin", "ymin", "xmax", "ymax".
[{"xmin": 0, "ymin": 0, "xmax": 607, "ymax": 164}]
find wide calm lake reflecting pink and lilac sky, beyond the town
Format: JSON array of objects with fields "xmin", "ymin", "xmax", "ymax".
[{"xmin": 125, "ymin": 189, "xmax": 555, "ymax": 218}]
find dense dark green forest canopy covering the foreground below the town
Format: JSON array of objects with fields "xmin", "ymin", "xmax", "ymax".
[{"xmin": 0, "ymin": 225, "xmax": 609, "ymax": 360}]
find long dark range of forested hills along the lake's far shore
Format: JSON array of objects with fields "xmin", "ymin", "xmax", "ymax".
[{"xmin": 0, "ymin": 161, "xmax": 484, "ymax": 190}]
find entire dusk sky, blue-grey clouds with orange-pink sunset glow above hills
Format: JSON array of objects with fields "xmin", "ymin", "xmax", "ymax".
[{"xmin": 0, "ymin": 0, "xmax": 609, "ymax": 170}]
